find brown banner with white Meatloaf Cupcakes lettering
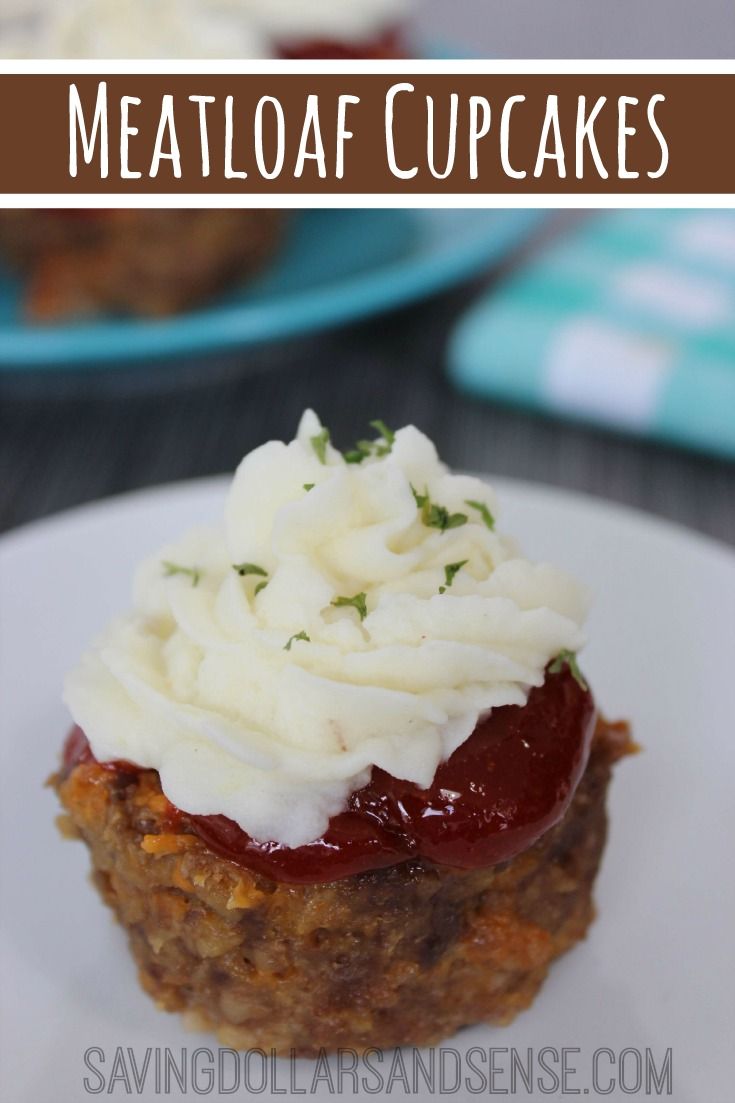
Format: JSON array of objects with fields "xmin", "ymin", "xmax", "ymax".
[{"xmin": 0, "ymin": 72, "xmax": 735, "ymax": 197}]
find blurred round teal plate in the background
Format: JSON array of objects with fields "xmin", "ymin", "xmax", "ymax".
[{"xmin": 0, "ymin": 210, "xmax": 544, "ymax": 372}]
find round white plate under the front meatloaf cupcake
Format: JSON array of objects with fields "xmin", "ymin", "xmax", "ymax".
[{"xmin": 0, "ymin": 480, "xmax": 735, "ymax": 1103}]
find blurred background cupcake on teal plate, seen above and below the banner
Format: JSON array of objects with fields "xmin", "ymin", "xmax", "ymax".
[{"xmin": 0, "ymin": 0, "xmax": 409, "ymax": 321}]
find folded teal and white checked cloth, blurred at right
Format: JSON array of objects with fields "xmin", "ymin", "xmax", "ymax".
[{"xmin": 449, "ymin": 211, "xmax": 735, "ymax": 458}]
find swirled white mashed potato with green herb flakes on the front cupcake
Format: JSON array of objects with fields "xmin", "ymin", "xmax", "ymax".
[{"xmin": 65, "ymin": 411, "xmax": 586, "ymax": 847}]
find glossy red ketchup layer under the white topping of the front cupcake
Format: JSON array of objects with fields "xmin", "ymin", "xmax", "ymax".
[{"xmin": 64, "ymin": 668, "xmax": 595, "ymax": 884}]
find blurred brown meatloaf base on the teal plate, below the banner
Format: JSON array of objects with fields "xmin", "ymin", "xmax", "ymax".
[{"xmin": 0, "ymin": 210, "xmax": 284, "ymax": 321}]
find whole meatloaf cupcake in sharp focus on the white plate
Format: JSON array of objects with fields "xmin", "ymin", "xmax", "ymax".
[{"xmin": 53, "ymin": 413, "xmax": 630, "ymax": 1054}]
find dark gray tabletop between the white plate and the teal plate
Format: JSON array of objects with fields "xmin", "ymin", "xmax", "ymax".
[{"xmin": 0, "ymin": 270, "xmax": 735, "ymax": 544}]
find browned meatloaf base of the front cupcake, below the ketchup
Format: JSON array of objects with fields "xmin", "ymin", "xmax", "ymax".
[{"xmin": 53, "ymin": 721, "xmax": 631, "ymax": 1054}]
